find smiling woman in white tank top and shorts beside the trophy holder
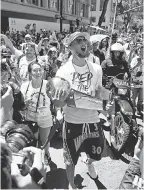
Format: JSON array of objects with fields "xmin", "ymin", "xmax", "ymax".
[{"xmin": 21, "ymin": 62, "xmax": 53, "ymax": 163}]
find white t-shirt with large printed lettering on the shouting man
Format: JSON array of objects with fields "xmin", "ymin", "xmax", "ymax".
[{"xmin": 56, "ymin": 60, "xmax": 102, "ymax": 124}]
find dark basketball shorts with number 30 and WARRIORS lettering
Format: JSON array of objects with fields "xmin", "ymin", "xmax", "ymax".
[{"xmin": 63, "ymin": 122, "xmax": 104, "ymax": 165}]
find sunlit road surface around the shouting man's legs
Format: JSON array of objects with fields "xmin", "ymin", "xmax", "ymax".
[{"xmin": 47, "ymin": 134, "xmax": 128, "ymax": 189}]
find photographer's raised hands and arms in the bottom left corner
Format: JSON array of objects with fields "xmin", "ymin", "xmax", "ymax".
[{"xmin": 1, "ymin": 143, "xmax": 46, "ymax": 189}]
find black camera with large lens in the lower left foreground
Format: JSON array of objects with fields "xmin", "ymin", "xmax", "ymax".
[{"xmin": 1, "ymin": 121, "xmax": 35, "ymax": 176}]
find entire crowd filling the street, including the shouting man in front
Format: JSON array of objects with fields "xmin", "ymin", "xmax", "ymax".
[{"xmin": 0, "ymin": 26, "xmax": 144, "ymax": 189}]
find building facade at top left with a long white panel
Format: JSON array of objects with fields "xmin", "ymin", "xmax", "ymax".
[{"xmin": 1, "ymin": 0, "xmax": 91, "ymax": 32}]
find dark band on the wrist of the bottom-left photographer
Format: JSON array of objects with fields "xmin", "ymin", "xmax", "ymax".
[{"xmin": 29, "ymin": 168, "xmax": 45, "ymax": 186}]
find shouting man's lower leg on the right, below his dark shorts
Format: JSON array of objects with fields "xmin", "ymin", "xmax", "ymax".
[{"xmin": 83, "ymin": 158, "xmax": 98, "ymax": 179}]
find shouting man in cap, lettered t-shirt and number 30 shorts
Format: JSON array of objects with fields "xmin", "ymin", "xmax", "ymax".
[{"xmin": 56, "ymin": 32, "xmax": 111, "ymax": 189}]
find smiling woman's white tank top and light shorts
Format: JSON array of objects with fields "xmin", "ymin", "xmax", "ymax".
[{"xmin": 21, "ymin": 80, "xmax": 53, "ymax": 128}]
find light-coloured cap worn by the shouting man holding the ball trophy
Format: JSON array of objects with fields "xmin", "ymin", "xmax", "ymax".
[{"xmin": 63, "ymin": 32, "xmax": 90, "ymax": 47}]
